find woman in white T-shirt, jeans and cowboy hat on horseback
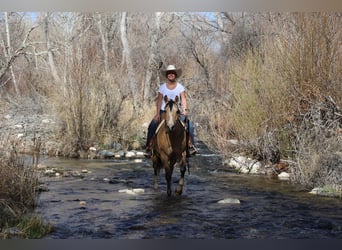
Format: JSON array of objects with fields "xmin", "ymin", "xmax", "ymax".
[{"xmin": 145, "ymin": 65, "xmax": 197, "ymax": 157}]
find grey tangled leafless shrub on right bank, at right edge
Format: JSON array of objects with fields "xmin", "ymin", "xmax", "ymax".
[{"xmin": 292, "ymin": 99, "xmax": 342, "ymax": 190}]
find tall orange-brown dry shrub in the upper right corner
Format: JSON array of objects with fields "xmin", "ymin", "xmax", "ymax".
[{"xmin": 274, "ymin": 12, "xmax": 342, "ymax": 108}]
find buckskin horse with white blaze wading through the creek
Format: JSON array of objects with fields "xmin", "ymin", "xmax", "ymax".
[{"xmin": 151, "ymin": 95, "xmax": 189, "ymax": 196}]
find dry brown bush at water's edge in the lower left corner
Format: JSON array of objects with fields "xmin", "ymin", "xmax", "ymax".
[{"xmin": 0, "ymin": 136, "xmax": 51, "ymax": 238}]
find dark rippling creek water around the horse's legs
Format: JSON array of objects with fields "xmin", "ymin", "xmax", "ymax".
[{"xmin": 35, "ymin": 145, "xmax": 342, "ymax": 239}]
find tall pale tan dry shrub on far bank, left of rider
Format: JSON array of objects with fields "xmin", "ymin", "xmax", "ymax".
[{"xmin": 50, "ymin": 68, "xmax": 126, "ymax": 155}]
